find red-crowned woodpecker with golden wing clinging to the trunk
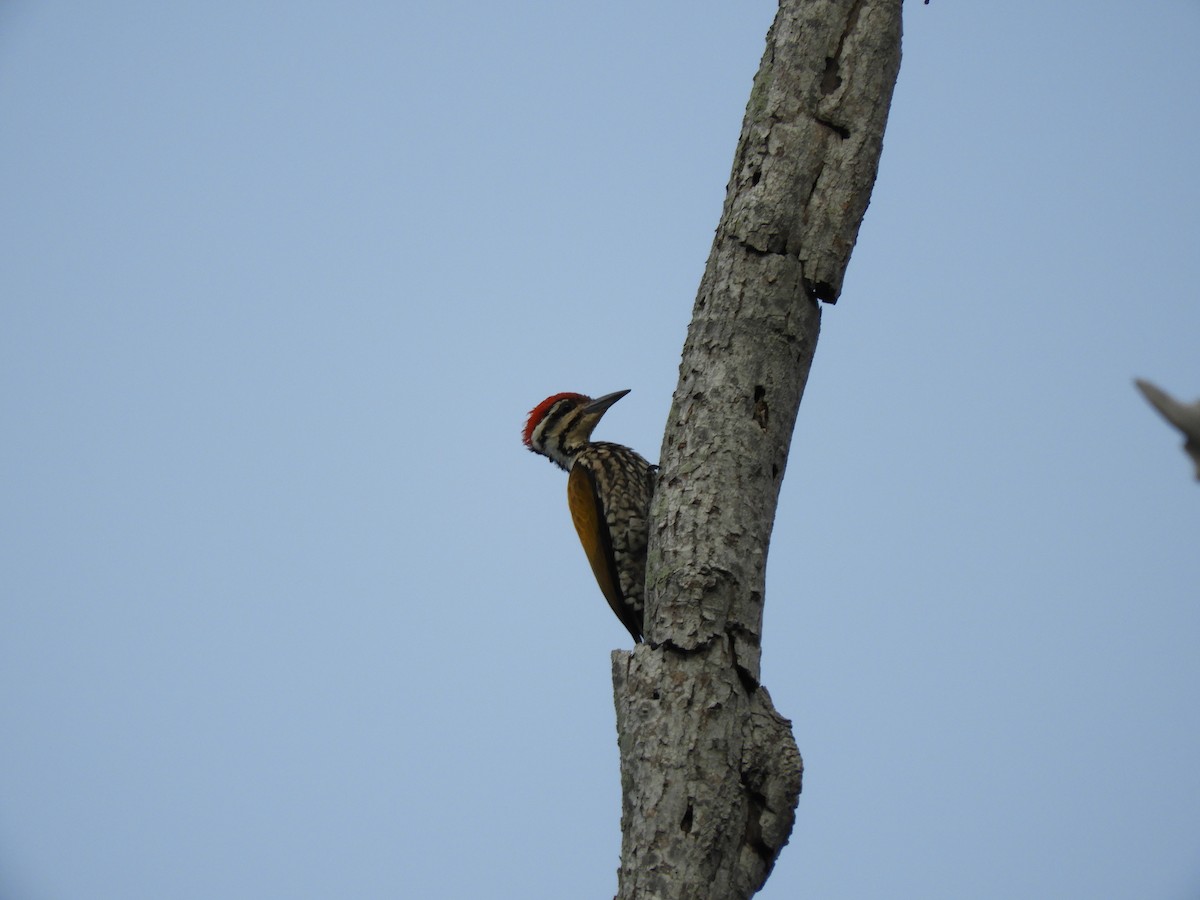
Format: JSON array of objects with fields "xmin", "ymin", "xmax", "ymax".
[{"xmin": 524, "ymin": 390, "xmax": 658, "ymax": 643}]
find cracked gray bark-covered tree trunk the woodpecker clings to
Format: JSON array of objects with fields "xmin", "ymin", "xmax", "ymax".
[{"xmin": 613, "ymin": 0, "xmax": 901, "ymax": 900}]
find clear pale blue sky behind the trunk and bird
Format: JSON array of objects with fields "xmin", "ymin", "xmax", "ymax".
[{"xmin": 0, "ymin": 0, "xmax": 1200, "ymax": 900}]
